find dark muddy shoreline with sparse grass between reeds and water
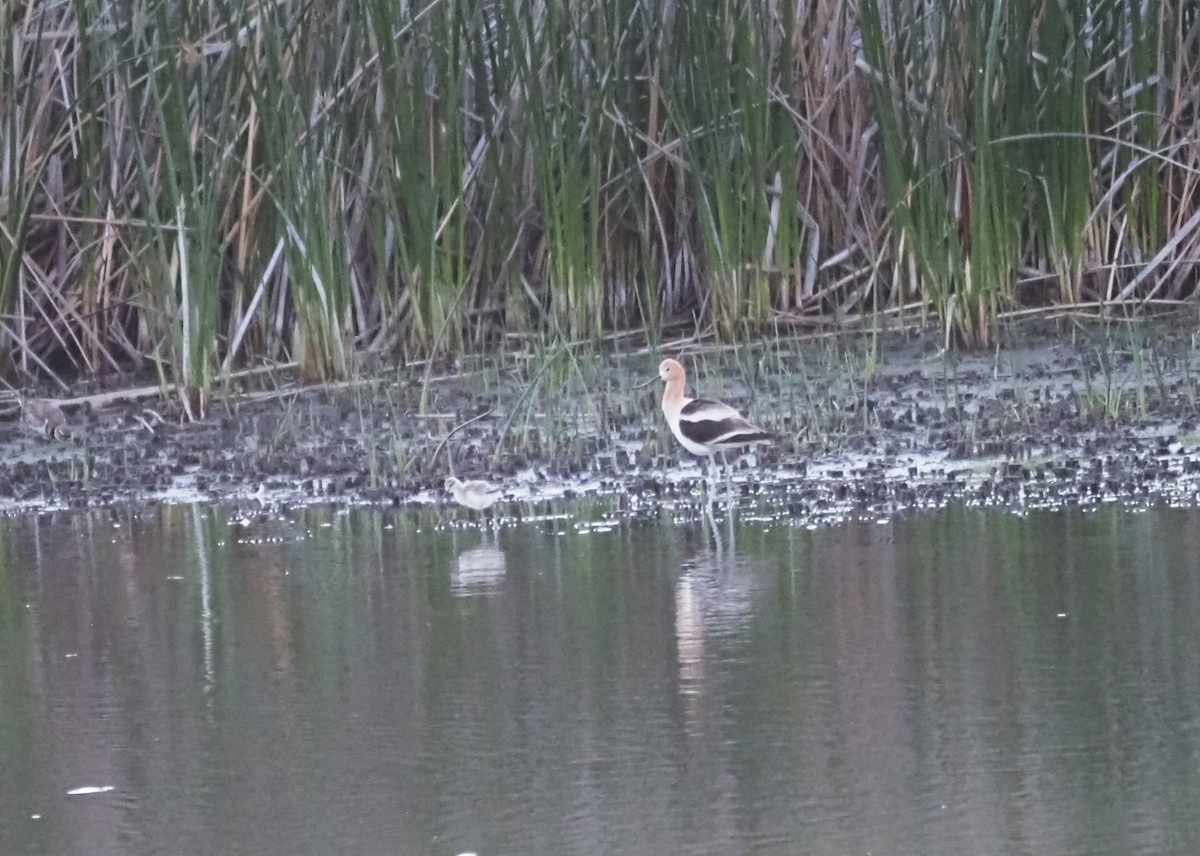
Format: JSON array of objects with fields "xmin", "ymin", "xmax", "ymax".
[{"xmin": 7, "ymin": 317, "xmax": 1200, "ymax": 521}]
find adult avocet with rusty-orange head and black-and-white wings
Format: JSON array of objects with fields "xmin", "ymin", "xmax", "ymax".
[{"xmin": 642, "ymin": 359, "xmax": 775, "ymax": 485}]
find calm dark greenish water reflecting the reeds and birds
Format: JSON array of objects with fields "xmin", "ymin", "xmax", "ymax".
[{"xmin": 0, "ymin": 505, "xmax": 1200, "ymax": 856}]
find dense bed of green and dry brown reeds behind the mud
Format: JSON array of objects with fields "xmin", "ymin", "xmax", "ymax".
[{"xmin": 0, "ymin": 0, "xmax": 1200, "ymax": 415}]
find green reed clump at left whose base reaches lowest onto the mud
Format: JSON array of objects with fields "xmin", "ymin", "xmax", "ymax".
[{"xmin": 127, "ymin": 5, "xmax": 242, "ymax": 418}]
